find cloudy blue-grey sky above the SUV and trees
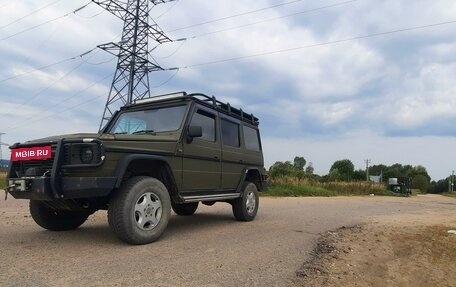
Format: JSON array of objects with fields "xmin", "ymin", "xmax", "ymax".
[{"xmin": 0, "ymin": 0, "xmax": 456, "ymax": 180}]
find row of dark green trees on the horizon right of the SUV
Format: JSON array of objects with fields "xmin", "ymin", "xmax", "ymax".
[{"xmin": 269, "ymin": 156, "xmax": 450, "ymax": 193}]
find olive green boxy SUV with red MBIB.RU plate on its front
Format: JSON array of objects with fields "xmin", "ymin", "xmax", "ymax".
[{"xmin": 7, "ymin": 92, "xmax": 267, "ymax": 244}]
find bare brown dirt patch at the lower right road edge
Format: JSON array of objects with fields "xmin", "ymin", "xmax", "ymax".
[{"xmin": 296, "ymin": 215, "xmax": 456, "ymax": 287}]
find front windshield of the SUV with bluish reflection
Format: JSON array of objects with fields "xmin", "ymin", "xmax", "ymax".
[{"xmin": 108, "ymin": 106, "xmax": 186, "ymax": 135}]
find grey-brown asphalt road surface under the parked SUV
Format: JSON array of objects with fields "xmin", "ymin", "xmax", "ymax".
[{"xmin": 0, "ymin": 195, "xmax": 456, "ymax": 286}]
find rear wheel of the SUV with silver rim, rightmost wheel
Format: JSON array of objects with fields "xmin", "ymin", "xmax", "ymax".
[{"xmin": 232, "ymin": 181, "xmax": 260, "ymax": 221}]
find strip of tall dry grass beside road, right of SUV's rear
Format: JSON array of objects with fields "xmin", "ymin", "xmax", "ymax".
[{"xmin": 263, "ymin": 177, "xmax": 401, "ymax": 197}]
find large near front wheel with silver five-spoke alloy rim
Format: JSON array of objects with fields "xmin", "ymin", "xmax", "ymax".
[{"xmin": 108, "ymin": 176, "xmax": 171, "ymax": 245}]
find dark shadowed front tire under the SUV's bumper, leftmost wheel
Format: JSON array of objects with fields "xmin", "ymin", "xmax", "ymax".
[{"xmin": 29, "ymin": 200, "xmax": 90, "ymax": 231}]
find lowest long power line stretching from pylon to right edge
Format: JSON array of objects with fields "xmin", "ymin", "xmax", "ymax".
[{"xmin": 172, "ymin": 20, "xmax": 456, "ymax": 70}]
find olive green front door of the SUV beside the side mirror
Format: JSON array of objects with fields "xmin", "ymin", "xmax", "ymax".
[{"xmin": 182, "ymin": 105, "xmax": 221, "ymax": 192}]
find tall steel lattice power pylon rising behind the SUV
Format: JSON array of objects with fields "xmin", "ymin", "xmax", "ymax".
[{"xmin": 92, "ymin": 0, "xmax": 175, "ymax": 129}]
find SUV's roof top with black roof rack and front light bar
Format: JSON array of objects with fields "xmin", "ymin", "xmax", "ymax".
[{"xmin": 121, "ymin": 92, "xmax": 259, "ymax": 125}]
